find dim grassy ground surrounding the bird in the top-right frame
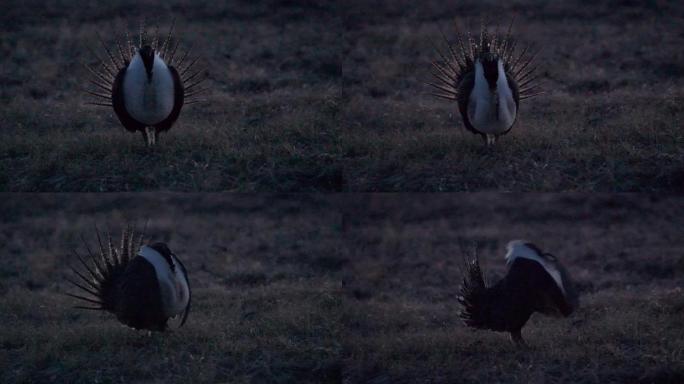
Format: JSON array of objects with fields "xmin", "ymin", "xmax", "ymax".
[{"xmin": 340, "ymin": 0, "xmax": 684, "ymax": 191}]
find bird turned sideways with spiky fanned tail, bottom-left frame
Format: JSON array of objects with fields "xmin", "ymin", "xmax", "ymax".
[{"xmin": 66, "ymin": 225, "xmax": 192, "ymax": 331}]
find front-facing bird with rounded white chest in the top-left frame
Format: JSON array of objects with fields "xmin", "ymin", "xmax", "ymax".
[{"xmin": 85, "ymin": 20, "xmax": 207, "ymax": 147}]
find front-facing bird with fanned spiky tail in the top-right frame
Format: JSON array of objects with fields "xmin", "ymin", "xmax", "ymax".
[{"xmin": 428, "ymin": 20, "xmax": 543, "ymax": 147}]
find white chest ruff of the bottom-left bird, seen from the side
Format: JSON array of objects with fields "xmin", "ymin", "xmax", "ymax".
[{"xmin": 138, "ymin": 245, "xmax": 190, "ymax": 317}]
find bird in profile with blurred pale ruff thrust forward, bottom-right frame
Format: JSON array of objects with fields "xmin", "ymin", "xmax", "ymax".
[{"xmin": 458, "ymin": 240, "xmax": 579, "ymax": 346}]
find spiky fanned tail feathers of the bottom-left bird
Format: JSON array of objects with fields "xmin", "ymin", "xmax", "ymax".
[{"xmin": 66, "ymin": 224, "xmax": 147, "ymax": 312}]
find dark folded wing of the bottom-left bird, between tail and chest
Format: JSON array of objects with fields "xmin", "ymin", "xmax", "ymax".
[{"xmin": 116, "ymin": 256, "xmax": 167, "ymax": 331}]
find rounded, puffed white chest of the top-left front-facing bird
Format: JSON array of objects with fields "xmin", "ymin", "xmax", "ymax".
[{"xmin": 123, "ymin": 54, "xmax": 174, "ymax": 125}]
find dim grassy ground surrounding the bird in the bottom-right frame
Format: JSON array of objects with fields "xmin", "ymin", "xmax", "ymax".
[{"xmin": 343, "ymin": 194, "xmax": 684, "ymax": 384}]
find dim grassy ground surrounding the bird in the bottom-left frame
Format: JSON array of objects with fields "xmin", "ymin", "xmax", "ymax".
[{"xmin": 0, "ymin": 194, "xmax": 345, "ymax": 383}]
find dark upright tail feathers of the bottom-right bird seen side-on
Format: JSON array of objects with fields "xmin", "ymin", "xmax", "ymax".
[{"xmin": 458, "ymin": 258, "xmax": 487, "ymax": 328}]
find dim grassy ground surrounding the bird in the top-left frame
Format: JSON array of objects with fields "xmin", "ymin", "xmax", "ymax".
[{"xmin": 0, "ymin": 0, "xmax": 342, "ymax": 191}]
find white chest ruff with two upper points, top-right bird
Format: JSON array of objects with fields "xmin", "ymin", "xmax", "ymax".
[{"xmin": 468, "ymin": 60, "xmax": 517, "ymax": 134}]
